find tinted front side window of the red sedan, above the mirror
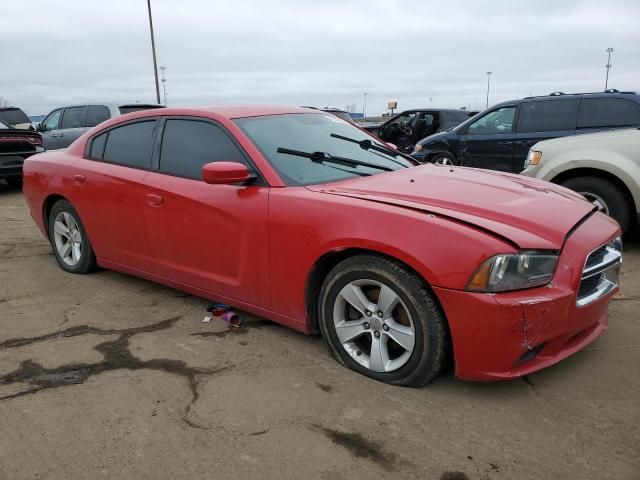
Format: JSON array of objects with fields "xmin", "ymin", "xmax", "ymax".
[{"xmin": 160, "ymin": 120, "xmax": 246, "ymax": 179}]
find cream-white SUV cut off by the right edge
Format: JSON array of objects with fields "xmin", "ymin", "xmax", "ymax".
[{"xmin": 522, "ymin": 128, "xmax": 640, "ymax": 232}]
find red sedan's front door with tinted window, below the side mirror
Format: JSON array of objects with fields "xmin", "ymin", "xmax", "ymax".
[{"xmin": 144, "ymin": 117, "xmax": 270, "ymax": 305}]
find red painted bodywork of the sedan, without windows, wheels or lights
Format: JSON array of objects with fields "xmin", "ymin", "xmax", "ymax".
[{"xmin": 24, "ymin": 107, "xmax": 619, "ymax": 379}]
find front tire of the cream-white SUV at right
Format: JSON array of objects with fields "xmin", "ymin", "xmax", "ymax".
[{"xmin": 562, "ymin": 177, "xmax": 631, "ymax": 233}]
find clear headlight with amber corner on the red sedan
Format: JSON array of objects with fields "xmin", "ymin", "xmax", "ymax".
[{"xmin": 467, "ymin": 250, "xmax": 558, "ymax": 292}]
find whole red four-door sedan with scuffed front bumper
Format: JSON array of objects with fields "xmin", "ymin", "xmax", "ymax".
[{"xmin": 24, "ymin": 107, "xmax": 622, "ymax": 386}]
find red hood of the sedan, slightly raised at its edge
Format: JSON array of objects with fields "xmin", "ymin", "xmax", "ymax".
[{"xmin": 308, "ymin": 164, "xmax": 595, "ymax": 250}]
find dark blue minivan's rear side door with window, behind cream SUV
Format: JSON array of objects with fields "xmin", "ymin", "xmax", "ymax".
[{"xmin": 513, "ymin": 98, "xmax": 580, "ymax": 173}]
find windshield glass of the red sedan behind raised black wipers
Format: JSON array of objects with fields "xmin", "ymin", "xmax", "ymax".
[{"xmin": 235, "ymin": 113, "xmax": 413, "ymax": 185}]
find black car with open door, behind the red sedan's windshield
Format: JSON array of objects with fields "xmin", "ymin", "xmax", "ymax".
[{"xmin": 360, "ymin": 109, "xmax": 469, "ymax": 153}]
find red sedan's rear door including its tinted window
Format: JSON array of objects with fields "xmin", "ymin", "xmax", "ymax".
[{"xmin": 70, "ymin": 119, "xmax": 158, "ymax": 273}]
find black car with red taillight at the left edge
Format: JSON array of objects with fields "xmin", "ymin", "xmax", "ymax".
[{"xmin": 0, "ymin": 121, "xmax": 44, "ymax": 187}]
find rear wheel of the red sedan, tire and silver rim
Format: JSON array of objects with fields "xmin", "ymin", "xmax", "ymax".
[{"xmin": 48, "ymin": 200, "xmax": 96, "ymax": 274}]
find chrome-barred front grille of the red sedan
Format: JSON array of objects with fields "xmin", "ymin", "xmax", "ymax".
[{"xmin": 576, "ymin": 237, "xmax": 622, "ymax": 307}]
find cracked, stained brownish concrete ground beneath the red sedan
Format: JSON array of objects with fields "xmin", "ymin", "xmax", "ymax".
[{"xmin": 0, "ymin": 186, "xmax": 640, "ymax": 480}]
